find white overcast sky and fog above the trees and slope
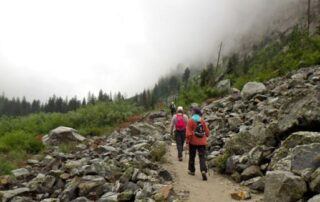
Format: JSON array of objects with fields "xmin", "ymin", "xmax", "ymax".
[{"xmin": 0, "ymin": 0, "xmax": 293, "ymax": 101}]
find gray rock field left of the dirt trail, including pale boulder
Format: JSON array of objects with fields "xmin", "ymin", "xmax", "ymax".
[{"xmin": 0, "ymin": 114, "xmax": 176, "ymax": 202}]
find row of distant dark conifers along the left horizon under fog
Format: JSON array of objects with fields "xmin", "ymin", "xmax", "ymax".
[{"xmin": 0, "ymin": 90, "xmax": 125, "ymax": 116}]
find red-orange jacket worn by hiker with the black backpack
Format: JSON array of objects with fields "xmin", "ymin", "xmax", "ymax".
[{"xmin": 186, "ymin": 118, "xmax": 210, "ymax": 145}]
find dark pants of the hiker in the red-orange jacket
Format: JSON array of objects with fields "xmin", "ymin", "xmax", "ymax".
[{"xmin": 189, "ymin": 144, "xmax": 207, "ymax": 172}]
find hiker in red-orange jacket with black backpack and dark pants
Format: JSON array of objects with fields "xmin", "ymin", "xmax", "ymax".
[{"xmin": 186, "ymin": 107, "xmax": 210, "ymax": 181}]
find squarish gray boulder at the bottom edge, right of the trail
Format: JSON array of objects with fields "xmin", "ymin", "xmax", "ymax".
[{"xmin": 264, "ymin": 171, "xmax": 307, "ymax": 202}]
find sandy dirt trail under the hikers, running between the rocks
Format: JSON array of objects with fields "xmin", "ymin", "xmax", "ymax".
[{"xmin": 165, "ymin": 144, "xmax": 263, "ymax": 202}]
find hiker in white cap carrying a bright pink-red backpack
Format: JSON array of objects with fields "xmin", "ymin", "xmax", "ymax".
[{"xmin": 170, "ymin": 106, "xmax": 188, "ymax": 161}]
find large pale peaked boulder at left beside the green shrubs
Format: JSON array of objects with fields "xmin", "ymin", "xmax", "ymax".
[{"xmin": 42, "ymin": 126, "xmax": 86, "ymax": 145}]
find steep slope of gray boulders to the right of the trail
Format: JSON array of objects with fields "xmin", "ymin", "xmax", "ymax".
[{"xmin": 203, "ymin": 66, "xmax": 320, "ymax": 202}]
